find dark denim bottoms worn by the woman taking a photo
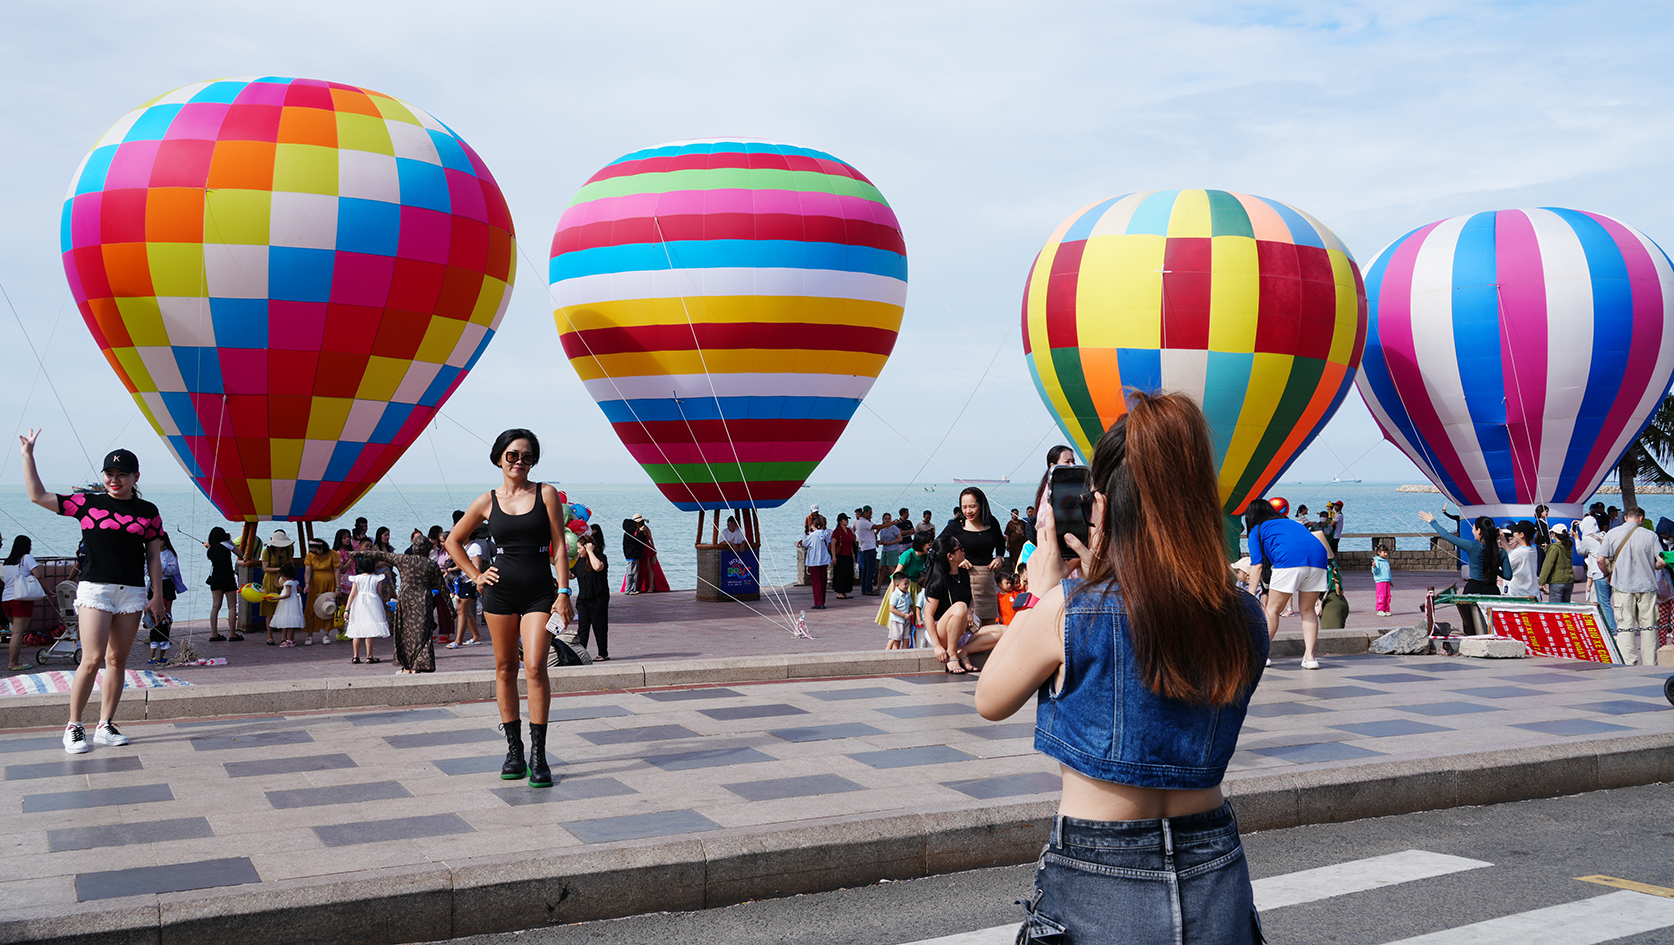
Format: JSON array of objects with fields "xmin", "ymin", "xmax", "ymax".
[{"xmin": 1018, "ymin": 805, "xmax": 1266, "ymax": 945}]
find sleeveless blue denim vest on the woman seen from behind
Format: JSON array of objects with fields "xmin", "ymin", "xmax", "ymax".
[{"xmin": 1035, "ymin": 580, "xmax": 1267, "ymax": 791}]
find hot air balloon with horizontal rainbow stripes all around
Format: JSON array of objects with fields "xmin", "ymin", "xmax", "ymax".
[{"xmin": 551, "ymin": 137, "xmax": 907, "ymax": 512}]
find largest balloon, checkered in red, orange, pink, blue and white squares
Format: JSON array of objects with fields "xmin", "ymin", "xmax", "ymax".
[{"xmin": 62, "ymin": 77, "xmax": 514, "ymax": 522}]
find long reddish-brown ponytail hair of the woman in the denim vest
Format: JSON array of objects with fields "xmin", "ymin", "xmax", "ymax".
[{"xmin": 1081, "ymin": 391, "xmax": 1257, "ymax": 706}]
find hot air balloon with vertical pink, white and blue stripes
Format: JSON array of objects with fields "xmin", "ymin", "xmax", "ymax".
[{"xmin": 1358, "ymin": 207, "xmax": 1674, "ymax": 518}]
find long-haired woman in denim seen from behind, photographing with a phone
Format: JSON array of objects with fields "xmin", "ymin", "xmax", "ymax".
[{"xmin": 976, "ymin": 395, "xmax": 1267, "ymax": 943}]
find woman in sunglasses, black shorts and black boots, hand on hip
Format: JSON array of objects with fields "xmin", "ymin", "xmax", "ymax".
[{"xmin": 445, "ymin": 428, "xmax": 574, "ymax": 788}]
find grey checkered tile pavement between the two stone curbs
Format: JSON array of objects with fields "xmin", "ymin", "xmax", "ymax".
[{"xmin": 0, "ymin": 656, "xmax": 1674, "ymax": 903}]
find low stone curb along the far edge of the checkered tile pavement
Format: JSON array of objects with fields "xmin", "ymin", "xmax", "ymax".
[{"xmin": 0, "ymin": 631, "xmax": 1381, "ymax": 731}]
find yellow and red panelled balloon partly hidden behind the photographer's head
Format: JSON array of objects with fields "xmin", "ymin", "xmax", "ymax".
[{"xmin": 1023, "ymin": 191, "xmax": 1366, "ymax": 513}]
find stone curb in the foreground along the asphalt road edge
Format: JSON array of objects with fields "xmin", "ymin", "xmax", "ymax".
[{"xmin": 0, "ymin": 734, "xmax": 1674, "ymax": 945}]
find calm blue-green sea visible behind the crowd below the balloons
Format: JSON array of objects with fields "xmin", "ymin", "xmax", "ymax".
[{"xmin": 13, "ymin": 482, "xmax": 1674, "ymax": 619}]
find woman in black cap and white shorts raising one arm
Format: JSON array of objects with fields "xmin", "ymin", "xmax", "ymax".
[{"xmin": 18, "ymin": 430, "xmax": 167, "ymax": 754}]
